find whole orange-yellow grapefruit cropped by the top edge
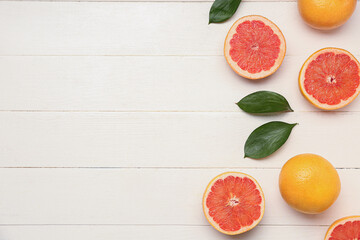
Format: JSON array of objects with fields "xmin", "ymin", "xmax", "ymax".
[{"xmin": 298, "ymin": 0, "xmax": 357, "ymax": 30}]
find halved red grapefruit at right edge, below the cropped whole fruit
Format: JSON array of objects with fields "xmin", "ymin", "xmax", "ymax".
[{"xmin": 299, "ymin": 48, "xmax": 360, "ymax": 110}]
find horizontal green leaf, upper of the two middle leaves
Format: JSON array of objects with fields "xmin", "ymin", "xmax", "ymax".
[{"xmin": 237, "ymin": 91, "xmax": 293, "ymax": 113}]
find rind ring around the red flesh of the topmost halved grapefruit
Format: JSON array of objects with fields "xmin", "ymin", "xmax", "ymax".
[{"xmin": 224, "ymin": 15, "xmax": 286, "ymax": 80}]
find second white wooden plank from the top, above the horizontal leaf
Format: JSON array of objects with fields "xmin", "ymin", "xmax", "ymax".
[{"xmin": 0, "ymin": 55, "xmax": 360, "ymax": 112}]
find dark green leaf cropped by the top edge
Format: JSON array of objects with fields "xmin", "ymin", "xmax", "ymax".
[{"xmin": 209, "ymin": 0, "xmax": 241, "ymax": 24}]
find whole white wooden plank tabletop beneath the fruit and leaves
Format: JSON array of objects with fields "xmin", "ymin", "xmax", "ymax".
[{"xmin": 0, "ymin": 0, "xmax": 360, "ymax": 240}]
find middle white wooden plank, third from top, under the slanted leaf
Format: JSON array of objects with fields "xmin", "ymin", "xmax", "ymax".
[{"xmin": 0, "ymin": 112, "xmax": 360, "ymax": 168}]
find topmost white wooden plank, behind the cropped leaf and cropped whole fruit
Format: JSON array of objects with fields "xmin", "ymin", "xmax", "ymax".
[{"xmin": 0, "ymin": 2, "xmax": 360, "ymax": 56}]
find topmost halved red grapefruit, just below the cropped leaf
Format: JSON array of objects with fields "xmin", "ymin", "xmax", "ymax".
[{"xmin": 224, "ymin": 15, "xmax": 286, "ymax": 79}]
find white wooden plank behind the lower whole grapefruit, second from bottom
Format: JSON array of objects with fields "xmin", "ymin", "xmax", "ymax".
[{"xmin": 0, "ymin": 168, "xmax": 360, "ymax": 226}]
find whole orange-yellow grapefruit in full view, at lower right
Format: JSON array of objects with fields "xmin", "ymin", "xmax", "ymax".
[{"xmin": 279, "ymin": 153, "xmax": 341, "ymax": 214}]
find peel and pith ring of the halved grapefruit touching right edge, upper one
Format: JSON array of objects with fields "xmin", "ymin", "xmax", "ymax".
[{"xmin": 298, "ymin": 47, "xmax": 360, "ymax": 110}]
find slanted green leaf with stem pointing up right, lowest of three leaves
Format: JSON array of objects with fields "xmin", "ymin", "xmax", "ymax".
[{"xmin": 244, "ymin": 121, "xmax": 297, "ymax": 159}]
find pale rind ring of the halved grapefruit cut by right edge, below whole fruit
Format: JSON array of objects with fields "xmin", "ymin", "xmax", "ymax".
[{"xmin": 299, "ymin": 47, "xmax": 360, "ymax": 110}]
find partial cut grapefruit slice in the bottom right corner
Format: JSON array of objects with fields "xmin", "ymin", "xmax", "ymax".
[{"xmin": 325, "ymin": 216, "xmax": 360, "ymax": 240}]
